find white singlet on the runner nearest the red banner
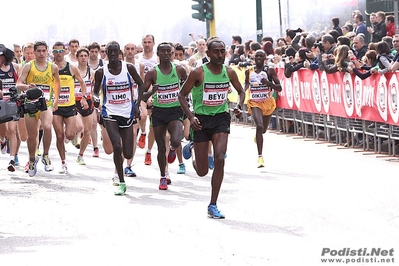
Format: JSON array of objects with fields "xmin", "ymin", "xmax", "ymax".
[{"xmin": 249, "ymin": 66, "xmax": 273, "ymax": 102}]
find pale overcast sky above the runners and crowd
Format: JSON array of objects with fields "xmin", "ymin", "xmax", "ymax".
[{"xmin": 0, "ymin": 0, "xmax": 360, "ymax": 46}]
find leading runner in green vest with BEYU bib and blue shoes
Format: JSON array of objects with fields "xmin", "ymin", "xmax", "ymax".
[{"xmin": 179, "ymin": 38, "xmax": 245, "ymax": 219}]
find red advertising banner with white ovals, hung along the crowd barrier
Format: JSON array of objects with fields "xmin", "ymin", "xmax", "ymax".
[{"xmin": 276, "ymin": 68, "xmax": 399, "ymax": 125}]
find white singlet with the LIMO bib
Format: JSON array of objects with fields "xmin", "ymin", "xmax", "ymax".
[{"xmin": 101, "ymin": 61, "xmax": 134, "ymax": 119}]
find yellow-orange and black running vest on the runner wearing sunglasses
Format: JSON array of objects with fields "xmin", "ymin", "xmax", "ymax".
[{"xmin": 58, "ymin": 62, "xmax": 75, "ymax": 107}]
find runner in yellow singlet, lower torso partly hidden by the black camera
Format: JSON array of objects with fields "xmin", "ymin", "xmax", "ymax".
[{"xmin": 17, "ymin": 41, "xmax": 60, "ymax": 177}]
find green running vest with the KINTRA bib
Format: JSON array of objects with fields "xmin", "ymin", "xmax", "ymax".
[{"xmin": 152, "ymin": 63, "xmax": 180, "ymax": 108}]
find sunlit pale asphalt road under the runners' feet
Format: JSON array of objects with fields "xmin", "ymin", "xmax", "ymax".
[{"xmin": 0, "ymin": 124, "xmax": 399, "ymax": 266}]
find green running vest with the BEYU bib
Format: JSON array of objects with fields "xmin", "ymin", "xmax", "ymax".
[{"xmin": 191, "ymin": 64, "xmax": 230, "ymax": 116}]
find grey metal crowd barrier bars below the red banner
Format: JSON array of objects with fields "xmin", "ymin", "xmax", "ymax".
[{"xmin": 229, "ymin": 104, "xmax": 399, "ymax": 157}]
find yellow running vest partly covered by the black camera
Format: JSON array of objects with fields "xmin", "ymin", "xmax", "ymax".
[{"xmin": 26, "ymin": 60, "xmax": 54, "ymax": 102}]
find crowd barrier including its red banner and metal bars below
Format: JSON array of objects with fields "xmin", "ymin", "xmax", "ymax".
[{"xmin": 231, "ymin": 69, "xmax": 399, "ymax": 156}]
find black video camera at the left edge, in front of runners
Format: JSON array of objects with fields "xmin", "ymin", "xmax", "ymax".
[{"xmin": 0, "ymin": 87, "xmax": 47, "ymax": 124}]
